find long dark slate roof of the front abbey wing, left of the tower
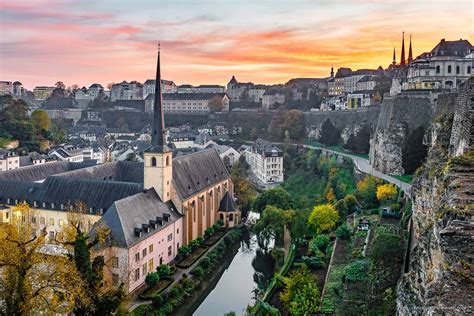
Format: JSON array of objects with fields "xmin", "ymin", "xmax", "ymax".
[{"xmin": 35, "ymin": 177, "xmax": 143, "ymax": 210}]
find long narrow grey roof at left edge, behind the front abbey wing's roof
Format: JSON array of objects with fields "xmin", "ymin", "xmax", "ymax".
[{"xmin": 0, "ymin": 161, "xmax": 95, "ymax": 182}]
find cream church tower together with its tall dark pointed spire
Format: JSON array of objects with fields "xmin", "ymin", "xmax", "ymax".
[{"xmin": 143, "ymin": 44, "xmax": 173, "ymax": 202}]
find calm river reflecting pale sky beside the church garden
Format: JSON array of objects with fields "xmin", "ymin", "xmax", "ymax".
[{"xmin": 193, "ymin": 220, "xmax": 275, "ymax": 316}]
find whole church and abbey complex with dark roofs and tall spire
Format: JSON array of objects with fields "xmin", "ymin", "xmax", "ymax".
[{"xmin": 0, "ymin": 45, "xmax": 240, "ymax": 292}]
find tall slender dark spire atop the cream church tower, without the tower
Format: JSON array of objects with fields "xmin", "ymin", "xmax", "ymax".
[{"xmin": 151, "ymin": 43, "xmax": 166, "ymax": 151}]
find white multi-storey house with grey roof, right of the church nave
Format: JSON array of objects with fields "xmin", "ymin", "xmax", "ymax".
[{"xmin": 244, "ymin": 138, "xmax": 283, "ymax": 184}]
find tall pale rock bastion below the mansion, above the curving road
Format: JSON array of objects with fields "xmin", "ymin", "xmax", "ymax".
[{"xmin": 369, "ymin": 95, "xmax": 432, "ymax": 174}]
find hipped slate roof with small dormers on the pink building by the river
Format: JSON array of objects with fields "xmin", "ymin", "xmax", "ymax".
[{"xmin": 97, "ymin": 189, "xmax": 181, "ymax": 248}]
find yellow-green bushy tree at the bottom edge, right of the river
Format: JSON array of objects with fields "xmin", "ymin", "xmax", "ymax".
[{"xmin": 280, "ymin": 266, "xmax": 320, "ymax": 315}]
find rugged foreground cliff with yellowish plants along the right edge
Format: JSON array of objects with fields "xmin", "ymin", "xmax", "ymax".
[{"xmin": 397, "ymin": 78, "xmax": 474, "ymax": 315}]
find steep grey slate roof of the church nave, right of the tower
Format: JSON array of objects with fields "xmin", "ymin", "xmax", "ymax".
[{"xmin": 173, "ymin": 148, "xmax": 230, "ymax": 199}]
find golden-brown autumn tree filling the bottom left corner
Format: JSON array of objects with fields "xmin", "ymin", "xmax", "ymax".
[{"xmin": 0, "ymin": 203, "xmax": 86, "ymax": 315}]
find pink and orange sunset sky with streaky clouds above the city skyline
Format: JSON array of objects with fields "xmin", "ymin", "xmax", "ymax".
[{"xmin": 0, "ymin": 0, "xmax": 474, "ymax": 89}]
